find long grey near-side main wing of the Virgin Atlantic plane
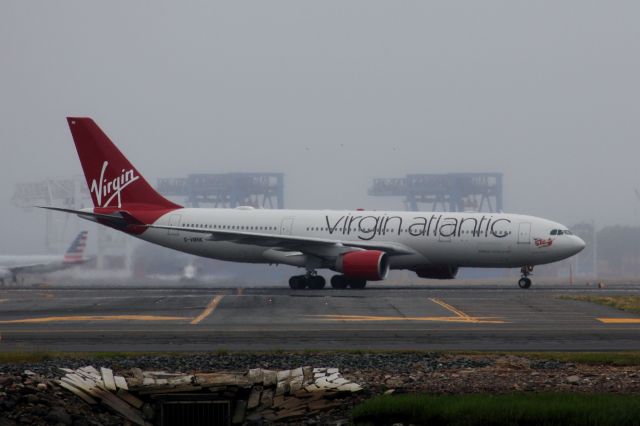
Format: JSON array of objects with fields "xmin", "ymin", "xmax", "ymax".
[{"xmin": 144, "ymin": 225, "xmax": 416, "ymax": 256}]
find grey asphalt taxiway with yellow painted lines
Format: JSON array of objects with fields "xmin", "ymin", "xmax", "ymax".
[{"xmin": 0, "ymin": 285, "xmax": 640, "ymax": 351}]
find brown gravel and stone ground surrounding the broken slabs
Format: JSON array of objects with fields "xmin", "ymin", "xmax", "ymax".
[{"xmin": 0, "ymin": 353, "xmax": 640, "ymax": 426}]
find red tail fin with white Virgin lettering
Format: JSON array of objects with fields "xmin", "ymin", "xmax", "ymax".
[{"xmin": 67, "ymin": 117, "xmax": 180, "ymax": 210}]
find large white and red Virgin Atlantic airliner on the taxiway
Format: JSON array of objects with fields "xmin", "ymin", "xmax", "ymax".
[{"xmin": 45, "ymin": 117, "xmax": 585, "ymax": 289}]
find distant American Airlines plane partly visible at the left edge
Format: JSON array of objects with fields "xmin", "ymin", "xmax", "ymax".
[{"xmin": 0, "ymin": 231, "xmax": 91, "ymax": 285}]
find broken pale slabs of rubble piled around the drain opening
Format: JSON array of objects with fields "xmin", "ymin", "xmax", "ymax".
[{"xmin": 55, "ymin": 366, "xmax": 363, "ymax": 426}]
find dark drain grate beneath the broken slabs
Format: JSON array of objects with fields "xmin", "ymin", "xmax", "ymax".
[{"xmin": 159, "ymin": 399, "xmax": 231, "ymax": 426}]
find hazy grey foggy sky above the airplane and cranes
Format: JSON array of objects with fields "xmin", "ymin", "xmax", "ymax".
[{"xmin": 0, "ymin": 0, "xmax": 640, "ymax": 253}]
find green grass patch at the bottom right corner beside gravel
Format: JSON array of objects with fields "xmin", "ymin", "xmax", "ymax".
[{"xmin": 352, "ymin": 393, "xmax": 640, "ymax": 426}]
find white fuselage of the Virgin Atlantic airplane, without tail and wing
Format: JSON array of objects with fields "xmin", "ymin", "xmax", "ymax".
[{"xmin": 139, "ymin": 208, "xmax": 584, "ymax": 269}]
